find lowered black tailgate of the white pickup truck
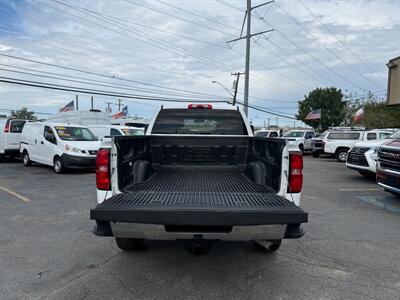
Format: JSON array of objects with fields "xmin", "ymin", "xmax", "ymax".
[{"xmin": 90, "ymin": 192, "xmax": 308, "ymax": 226}]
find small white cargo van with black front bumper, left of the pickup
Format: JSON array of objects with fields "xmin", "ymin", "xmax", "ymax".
[{"xmin": 20, "ymin": 122, "xmax": 100, "ymax": 173}]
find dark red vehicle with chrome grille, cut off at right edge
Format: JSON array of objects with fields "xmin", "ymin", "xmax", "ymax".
[{"xmin": 376, "ymin": 130, "xmax": 400, "ymax": 196}]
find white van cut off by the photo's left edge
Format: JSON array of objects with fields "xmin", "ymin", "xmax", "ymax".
[{"xmin": 0, "ymin": 119, "xmax": 26, "ymax": 159}]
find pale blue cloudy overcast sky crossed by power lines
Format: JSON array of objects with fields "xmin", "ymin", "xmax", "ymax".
[{"xmin": 0, "ymin": 0, "xmax": 400, "ymax": 125}]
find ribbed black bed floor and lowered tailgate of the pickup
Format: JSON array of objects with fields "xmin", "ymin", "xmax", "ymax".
[{"xmin": 91, "ymin": 166, "xmax": 307, "ymax": 226}]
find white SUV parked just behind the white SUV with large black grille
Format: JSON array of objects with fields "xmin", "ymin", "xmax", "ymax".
[{"xmin": 323, "ymin": 129, "xmax": 387, "ymax": 162}]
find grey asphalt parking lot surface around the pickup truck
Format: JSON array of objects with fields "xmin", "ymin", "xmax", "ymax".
[{"xmin": 0, "ymin": 156, "xmax": 400, "ymax": 299}]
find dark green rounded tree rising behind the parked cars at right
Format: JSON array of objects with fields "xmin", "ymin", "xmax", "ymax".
[{"xmin": 296, "ymin": 87, "xmax": 347, "ymax": 131}]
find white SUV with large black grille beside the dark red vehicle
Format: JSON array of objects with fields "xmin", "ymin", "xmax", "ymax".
[{"xmin": 346, "ymin": 130, "xmax": 393, "ymax": 177}]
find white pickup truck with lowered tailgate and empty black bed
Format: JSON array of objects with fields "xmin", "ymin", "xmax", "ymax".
[{"xmin": 90, "ymin": 104, "xmax": 308, "ymax": 254}]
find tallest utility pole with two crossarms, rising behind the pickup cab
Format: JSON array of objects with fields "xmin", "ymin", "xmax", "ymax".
[{"xmin": 226, "ymin": 0, "xmax": 274, "ymax": 116}]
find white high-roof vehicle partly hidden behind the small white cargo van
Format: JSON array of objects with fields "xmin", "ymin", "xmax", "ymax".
[{"xmin": 46, "ymin": 109, "xmax": 111, "ymax": 126}]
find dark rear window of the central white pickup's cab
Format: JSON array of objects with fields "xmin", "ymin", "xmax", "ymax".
[{"xmin": 152, "ymin": 109, "xmax": 247, "ymax": 135}]
